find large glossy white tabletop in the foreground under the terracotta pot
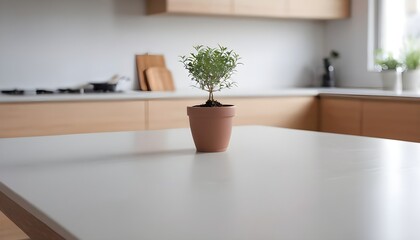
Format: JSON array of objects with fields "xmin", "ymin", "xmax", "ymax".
[{"xmin": 0, "ymin": 126, "xmax": 420, "ymax": 240}]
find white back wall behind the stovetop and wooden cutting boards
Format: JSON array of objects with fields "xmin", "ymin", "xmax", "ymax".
[{"xmin": 0, "ymin": 0, "xmax": 324, "ymax": 89}]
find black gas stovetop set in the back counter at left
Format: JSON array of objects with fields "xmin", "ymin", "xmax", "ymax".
[{"xmin": 1, "ymin": 88, "xmax": 120, "ymax": 95}]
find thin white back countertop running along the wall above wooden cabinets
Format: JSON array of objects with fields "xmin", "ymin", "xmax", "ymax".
[{"xmin": 0, "ymin": 88, "xmax": 420, "ymax": 103}]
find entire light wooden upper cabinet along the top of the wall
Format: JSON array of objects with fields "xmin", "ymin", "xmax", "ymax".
[{"xmin": 147, "ymin": 0, "xmax": 350, "ymax": 19}]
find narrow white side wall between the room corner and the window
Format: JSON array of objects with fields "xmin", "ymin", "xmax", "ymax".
[{"xmin": 325, "ymin": 0, "xmax": 381, "ymax": 88}]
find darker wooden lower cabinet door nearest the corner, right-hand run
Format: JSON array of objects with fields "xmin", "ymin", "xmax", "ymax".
[{"xmin": 320, "ymin": 97, "xmax": 362, "ymax": 135}]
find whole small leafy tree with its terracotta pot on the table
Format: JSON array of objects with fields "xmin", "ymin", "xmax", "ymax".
[{"xmin": 180, "ymin": 45, "xmax": 241, "ymax": 152}]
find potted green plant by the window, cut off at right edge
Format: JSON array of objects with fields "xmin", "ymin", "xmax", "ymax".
[{"xmin": 402, "ymin": 42, "xmax": 420, "ymax": 91}]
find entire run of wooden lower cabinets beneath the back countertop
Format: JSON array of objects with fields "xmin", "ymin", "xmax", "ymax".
[{"xmin": 4, "ymin": 95, "xmax": 420, "ymax": 142}]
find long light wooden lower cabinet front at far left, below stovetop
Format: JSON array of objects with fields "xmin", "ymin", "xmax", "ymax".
[{"xmin": 0, "ymin": 101, "xmax": 146, "ymax": 137}]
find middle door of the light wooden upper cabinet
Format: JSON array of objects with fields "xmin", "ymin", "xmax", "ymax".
[{"xmin": 233, "ymin": 0, "xmax": 289, "ymax": 17}]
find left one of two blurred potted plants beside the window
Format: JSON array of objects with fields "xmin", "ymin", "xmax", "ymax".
[{"xmin": 375, "ymin": 49, "xmax": 402, "ymax": 91}]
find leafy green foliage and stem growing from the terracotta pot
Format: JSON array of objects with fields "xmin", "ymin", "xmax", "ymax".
[{"xmin": 180, "ymin": 45, "xmax": 242, "ymax": 107}]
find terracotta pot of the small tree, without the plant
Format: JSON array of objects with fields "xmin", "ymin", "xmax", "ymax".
[{"xmin": 187, "ymin": 105, "xmax": 236, "ymax": 152}]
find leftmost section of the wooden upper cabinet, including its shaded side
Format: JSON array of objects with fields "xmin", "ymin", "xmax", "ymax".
[{"xmin": 146, "ymin": 0, "xmax": 233, "ymax": 15}]
